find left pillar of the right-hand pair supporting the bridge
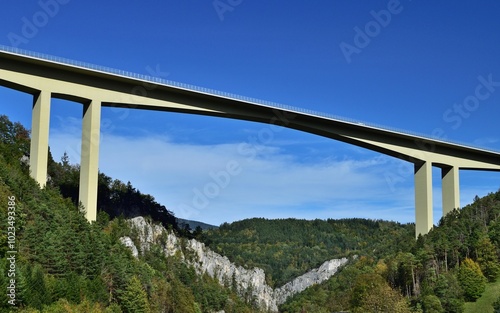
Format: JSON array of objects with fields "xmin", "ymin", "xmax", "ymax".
[{"xmin": 415, "ymin": 162, "xmax": 433, "ymax": 237}]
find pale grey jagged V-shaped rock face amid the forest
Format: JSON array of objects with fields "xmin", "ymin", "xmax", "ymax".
[{"xmin": 120, "ymin": 216, "xmax": 348, "ymax": 312}]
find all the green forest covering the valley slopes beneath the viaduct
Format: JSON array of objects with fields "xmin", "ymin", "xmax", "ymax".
[{"xmin": 0, "ymin": 112, "xmax": 500, "ymax": 313}]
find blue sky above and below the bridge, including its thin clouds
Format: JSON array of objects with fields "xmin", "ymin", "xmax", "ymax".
[{"xmin": 0, "ymin": 0, "xmax": 500, "ymax": 224}]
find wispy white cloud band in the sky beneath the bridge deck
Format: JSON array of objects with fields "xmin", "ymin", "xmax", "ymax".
[{"xmin": 46, "ymin": 116, "xmax": 491, "ymax": 225}]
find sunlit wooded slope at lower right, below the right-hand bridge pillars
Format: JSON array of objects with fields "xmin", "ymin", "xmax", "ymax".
[{"xmin": 281, "ymin": 192, "xmax": 500, "ymax": 312}]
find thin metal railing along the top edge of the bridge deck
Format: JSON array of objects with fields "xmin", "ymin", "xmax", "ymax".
[{"xmin": 0, "ymin": 45, "xmax": 499, "ymax": 153}]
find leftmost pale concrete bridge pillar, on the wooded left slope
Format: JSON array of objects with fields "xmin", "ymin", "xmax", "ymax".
[{"xmin": 30, "ymin": 91, "xmax": 51, "ymax": 188}]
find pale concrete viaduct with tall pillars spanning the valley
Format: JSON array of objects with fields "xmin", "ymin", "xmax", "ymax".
[{"xmin": 0, "ymin": 47, "xmax": 500, "ymax": 235}]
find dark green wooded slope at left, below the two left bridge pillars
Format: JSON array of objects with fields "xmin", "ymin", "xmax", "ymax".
[{"xmin": 0, "ymin": 116, "xmax": 255, "ymax": 313}]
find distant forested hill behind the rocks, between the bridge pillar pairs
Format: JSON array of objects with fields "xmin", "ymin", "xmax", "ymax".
[{"xmin": 201, "ymin": 218, "xmax": 415, "ymax": 287}]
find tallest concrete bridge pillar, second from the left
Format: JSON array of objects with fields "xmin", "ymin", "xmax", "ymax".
[{"xmin": 80, "ymin": 100, "xmax": 101, "ymax": 222}]
